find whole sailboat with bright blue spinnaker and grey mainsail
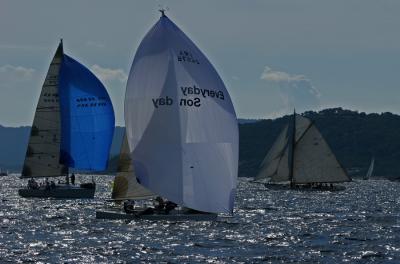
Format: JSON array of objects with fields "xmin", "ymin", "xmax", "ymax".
[{"xmin": 18, "ymin": 40, "xmax": 115, "ymax": 198}]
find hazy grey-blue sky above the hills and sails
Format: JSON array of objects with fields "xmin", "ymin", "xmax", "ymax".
[{"xmin": 0, "ymin": 0, "xmax": 400, "ymax": 126}]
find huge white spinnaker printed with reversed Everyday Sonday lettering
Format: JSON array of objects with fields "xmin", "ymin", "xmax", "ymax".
[{"xmin": 125, "ymin": 16, "xmax": 238, "ymax": 213}]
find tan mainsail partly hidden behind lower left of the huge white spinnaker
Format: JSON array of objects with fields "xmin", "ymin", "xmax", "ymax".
[{"xmin": 111, "ymin": 135, "xmax": 155, "ymax": 200}]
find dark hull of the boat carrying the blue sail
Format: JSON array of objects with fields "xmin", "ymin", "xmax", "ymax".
[{"xmin": 18, "ymin": 186, "xmax": 96, "ymax": 199}]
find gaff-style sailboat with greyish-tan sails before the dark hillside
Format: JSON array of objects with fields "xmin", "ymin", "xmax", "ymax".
[{"xmin": 255, "ymin": 113, "xmax": 351, "ymax": 189}]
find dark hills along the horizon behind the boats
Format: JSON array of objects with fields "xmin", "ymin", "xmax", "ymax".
[{"xmin": 0, "ymin": 108, "xmax": 400, "ymax": 178}]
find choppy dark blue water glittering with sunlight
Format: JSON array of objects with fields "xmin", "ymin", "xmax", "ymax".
[{"xmin": 0, "ymin": 175, "xmax": 400, "ymax": 263}]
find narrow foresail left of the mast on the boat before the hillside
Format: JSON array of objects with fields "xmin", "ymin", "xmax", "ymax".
[{"xmin": 255, "ymin": 125, "xmax": 288, "ymax": 180}]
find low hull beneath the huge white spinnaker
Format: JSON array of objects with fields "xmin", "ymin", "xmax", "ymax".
[{"xmin": 96, "ymin": 211, "xmax": 218, "ymax": 221}]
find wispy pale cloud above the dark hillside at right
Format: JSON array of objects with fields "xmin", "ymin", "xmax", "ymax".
[{"xmin": 260, "ymin": 66, "xmax": 321, "ymax": 112}]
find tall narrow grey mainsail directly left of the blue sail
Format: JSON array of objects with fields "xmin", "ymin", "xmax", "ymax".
[{"xmin": 21, "ymin": 44, "xmax": 68, "ymax": 178}]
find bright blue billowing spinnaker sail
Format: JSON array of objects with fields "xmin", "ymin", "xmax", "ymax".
[{"xmin": 59, "ymin": 54, "xmax": 115, "ymax": 171}]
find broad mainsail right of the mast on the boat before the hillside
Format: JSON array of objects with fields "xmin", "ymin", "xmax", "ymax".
[{"xmin": 293, "ymin": 125, "xmax": 350, "ymax": 183}]
